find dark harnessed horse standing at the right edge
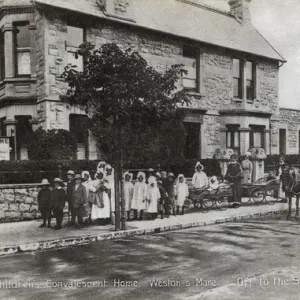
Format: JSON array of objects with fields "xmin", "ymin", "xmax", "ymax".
[{"xmin": 282, "ymin": 167, "xmax": 300, "ymax": 219}]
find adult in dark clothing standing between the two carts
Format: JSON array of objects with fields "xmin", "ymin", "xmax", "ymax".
[{"xmin": 225, "ymin": 154, "xmax": 243, "ymax": 208}]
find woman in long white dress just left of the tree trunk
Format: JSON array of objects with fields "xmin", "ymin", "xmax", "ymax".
[{"xmin": 89, "ymin": 169, "xmax": 110, "ymax": 225}]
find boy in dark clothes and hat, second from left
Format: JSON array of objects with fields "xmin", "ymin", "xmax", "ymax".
[{"xmin": 49, "ymin": 178, "xmax": 66, "ymax": 230}]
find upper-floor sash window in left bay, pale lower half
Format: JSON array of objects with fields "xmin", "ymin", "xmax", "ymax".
[{"xmin": 14, "ymin": 22, "xmax": 31, "ymax": 76}]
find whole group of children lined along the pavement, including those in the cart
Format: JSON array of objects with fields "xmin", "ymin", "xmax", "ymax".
[{"xmin": 38, "ymin": 162, "xmax": 218, "ymax": 230}]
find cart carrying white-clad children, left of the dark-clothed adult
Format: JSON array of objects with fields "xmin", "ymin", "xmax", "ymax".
[{"xmin": 189, "ymin": 184, "xmax": 232, "ymax": 210}]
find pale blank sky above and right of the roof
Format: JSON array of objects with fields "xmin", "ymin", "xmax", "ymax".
[{"xmin": 202, "ymin": 0, "xmax": 300, "ymax": 109}]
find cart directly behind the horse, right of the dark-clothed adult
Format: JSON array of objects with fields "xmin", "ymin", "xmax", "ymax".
[{"xmin": 243, "ymin": 178, "xmax": 280, "ymax": 204}]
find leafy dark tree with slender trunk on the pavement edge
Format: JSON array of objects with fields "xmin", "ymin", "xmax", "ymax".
[{"xmin": 62, "ymin": 43, "xmax": 189, "ymax": 230}]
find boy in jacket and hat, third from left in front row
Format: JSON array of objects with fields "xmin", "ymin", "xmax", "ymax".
[{"xmin": 72, "ymin": 174, "xmax": 87, "ymax": 229}]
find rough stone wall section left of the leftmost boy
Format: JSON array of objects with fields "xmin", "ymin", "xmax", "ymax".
[{"xmin": 0, "ymin": 184, "xmax": 44, "ymax": 222}]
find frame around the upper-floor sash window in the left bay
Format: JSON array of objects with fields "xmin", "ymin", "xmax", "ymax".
[{"xmin": 13, "ymin": 21, "xmax": 32, "ymax": 78}]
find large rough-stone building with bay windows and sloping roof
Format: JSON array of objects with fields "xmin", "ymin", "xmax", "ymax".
[{"xmin": 0, "ymin": 0, "xmax": 292, "ymax": 159}]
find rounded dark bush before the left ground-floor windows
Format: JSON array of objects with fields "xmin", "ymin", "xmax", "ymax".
[{"xmin": 26, "ymin": 128, "xmax": 77, "ymax": 160}]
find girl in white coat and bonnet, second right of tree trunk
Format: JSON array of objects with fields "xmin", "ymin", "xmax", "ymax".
[{"xmin": 131, "ymin": 172, "xmax": 147, "ymax": 220}]
